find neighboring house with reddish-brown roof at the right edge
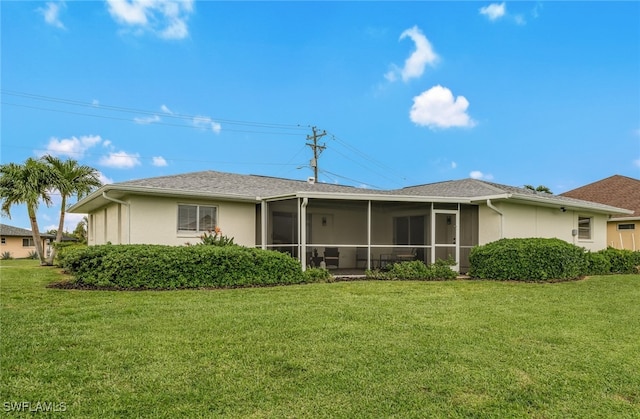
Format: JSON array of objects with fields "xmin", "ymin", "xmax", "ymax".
[{"xmin": 561, "ymin": 175, "xmax": 640, "ymax": 251}]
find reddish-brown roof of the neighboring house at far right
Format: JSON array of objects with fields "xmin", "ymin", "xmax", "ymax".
[{"xmin": 560, "ymin": 175, "xmax": 640, "ymax": 217}]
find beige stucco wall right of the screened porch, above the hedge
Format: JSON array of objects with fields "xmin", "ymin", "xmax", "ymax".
[{"xmin": 479, "ymin": 202, "xmax": 607, "ymax": 251}]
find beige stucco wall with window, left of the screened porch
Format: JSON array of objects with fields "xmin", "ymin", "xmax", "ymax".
[{"xmin": 89, "ymin": 196, "xmax": 256, "ymax": 246}]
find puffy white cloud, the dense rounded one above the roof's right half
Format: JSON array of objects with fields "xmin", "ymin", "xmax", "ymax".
[{"xmin": 409, "ymin": 85, "xmax": 476, "ymax": 129}]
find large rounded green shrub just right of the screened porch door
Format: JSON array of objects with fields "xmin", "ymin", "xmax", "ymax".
[{"xmin": 469, "ymin": 238, "xmax": 587, "ymax": 281}]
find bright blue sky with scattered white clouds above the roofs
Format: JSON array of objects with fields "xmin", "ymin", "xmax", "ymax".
[{"xmin": 0, "ymin": 0, "xmax": 640, "ymax": 230}]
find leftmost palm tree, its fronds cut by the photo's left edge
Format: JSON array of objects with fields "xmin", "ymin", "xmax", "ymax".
[{"xmin": 0, "ymin": 157, "xmax": 52, "ymax": 265}]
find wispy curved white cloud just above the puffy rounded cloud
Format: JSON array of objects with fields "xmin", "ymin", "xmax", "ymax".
[{"xmin": 384, "ymin": 26, "xmax": 439, "ymax": 82}]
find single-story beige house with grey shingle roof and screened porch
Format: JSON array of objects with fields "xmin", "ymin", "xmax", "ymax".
[{"xmin": 69, "ymin": 171, "xmax": 630, "ymax": 272}]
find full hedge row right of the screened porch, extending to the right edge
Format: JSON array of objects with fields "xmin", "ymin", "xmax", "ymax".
[{"xmin": 469, "ymin": 238, "xmax": 640, "ymax": 281}]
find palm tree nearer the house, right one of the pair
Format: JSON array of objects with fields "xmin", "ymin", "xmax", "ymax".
[{"xmin": 42, "ymin": 155, "xmax": 102, "ymax": 263}]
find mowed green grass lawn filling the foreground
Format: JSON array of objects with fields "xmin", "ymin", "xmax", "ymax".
[{"xmin": 0, "ymin": 260, "xmax": 640, "ymax": 418}]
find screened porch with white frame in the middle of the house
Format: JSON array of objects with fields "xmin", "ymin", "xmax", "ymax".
[{"xmin": 256, "ymin": 196, "xmax": 478, "ymax": 272}]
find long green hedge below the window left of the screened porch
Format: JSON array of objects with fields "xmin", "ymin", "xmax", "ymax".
[{"xmin": 58, "ymin": 245, "xmax": 309, "ymax": 289}]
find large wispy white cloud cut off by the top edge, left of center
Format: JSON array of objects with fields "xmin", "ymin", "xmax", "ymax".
[{"xmin": 107, "ymin": 0, "xmax": 193, "ymax": 39}]
